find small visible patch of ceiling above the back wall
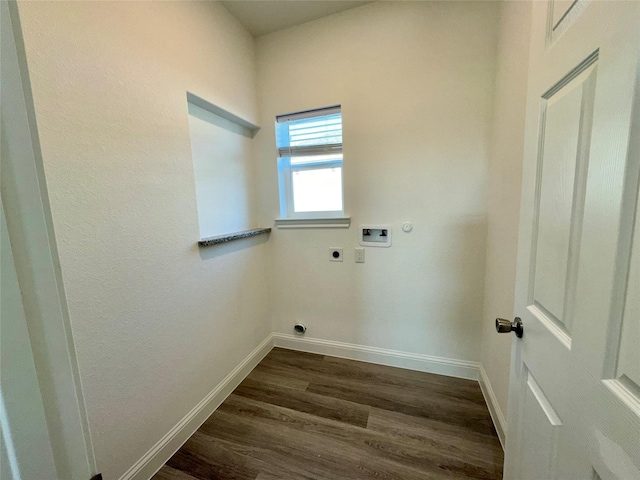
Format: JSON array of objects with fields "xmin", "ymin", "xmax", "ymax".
[{"xmin": 220, "ymin": 0, "xmax": 371, "ymax": 37}]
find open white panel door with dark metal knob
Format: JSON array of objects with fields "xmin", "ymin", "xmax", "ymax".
[{"xmin": 505, "ymin": 0, "xmax": 640, "ymax": 480}]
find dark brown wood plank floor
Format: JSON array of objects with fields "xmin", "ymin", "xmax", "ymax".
[{"xmin": 153, "ymin": 348, "xmax": 503, "ymax": 480}]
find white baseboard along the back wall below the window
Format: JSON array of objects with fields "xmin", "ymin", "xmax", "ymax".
[{"xmin": 273, "ymin": 333, "xmax": 480, "ymax": 380}]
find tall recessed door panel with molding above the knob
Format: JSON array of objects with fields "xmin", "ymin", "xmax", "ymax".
[{"xmin": 529, "ymin": 55, "xmax": 599, "ymax": 342}]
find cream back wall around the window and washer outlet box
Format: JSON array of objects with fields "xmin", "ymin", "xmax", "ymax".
[{"xmin": 255, "ymin": 2, "xmax": 499, "ymax": 360}]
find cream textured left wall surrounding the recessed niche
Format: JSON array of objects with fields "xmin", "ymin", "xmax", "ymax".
[{"xmin": 19, "ymin": 2, "xmax": 271, "ymax": 480}]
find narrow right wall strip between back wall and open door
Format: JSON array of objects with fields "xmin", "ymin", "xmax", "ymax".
[{"xmin": 480, "ymin": 2, "xmax": 531, "ymax": 424}]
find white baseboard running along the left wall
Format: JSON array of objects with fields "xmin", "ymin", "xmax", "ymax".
[{"xmin": 120, "ymin": 334, "xmax": 273, "ymax": 480}]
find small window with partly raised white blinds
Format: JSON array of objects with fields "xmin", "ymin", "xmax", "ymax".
[{"xmin": 276, "ymin": 105, "xmax": 344, "ymax": 219}]
